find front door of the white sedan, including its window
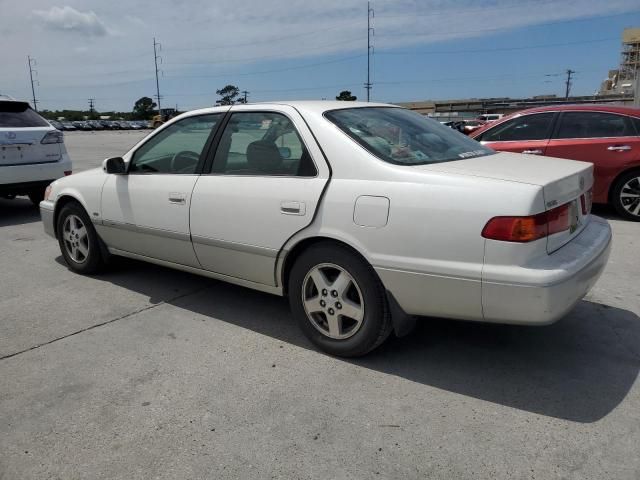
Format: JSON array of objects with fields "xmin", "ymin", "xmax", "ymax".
[{"xmin": 99, "ymin": 113, "xmax": 224, "ymax": 267}]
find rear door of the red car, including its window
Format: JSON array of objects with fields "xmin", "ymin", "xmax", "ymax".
[{"xmin": 547, "ymin": 111, "xmax": 640, "ymax": 199}]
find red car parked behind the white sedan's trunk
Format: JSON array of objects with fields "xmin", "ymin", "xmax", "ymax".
[{"xmin": 470, "ymin": 105, "xmax": 640, "ymax": 221}]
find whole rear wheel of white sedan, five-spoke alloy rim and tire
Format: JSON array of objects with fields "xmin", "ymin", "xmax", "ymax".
[{"xmin": 289, "ymin": 243, "xmax": 392, "ymax": 357}]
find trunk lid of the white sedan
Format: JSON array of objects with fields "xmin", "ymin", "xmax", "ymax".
[{"xmin": 415, "ymin": 152, "xmax": 593, "ymax": 253}]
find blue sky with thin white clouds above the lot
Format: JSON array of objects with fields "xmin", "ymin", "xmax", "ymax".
[{"xmin": 0, "ymin": 0, "xmax": 640, "ymax": 111}]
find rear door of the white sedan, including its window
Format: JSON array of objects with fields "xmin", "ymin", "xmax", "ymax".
[{"xmin": 191, "ymin": 106, "xmax": 329, "ymax": 285}]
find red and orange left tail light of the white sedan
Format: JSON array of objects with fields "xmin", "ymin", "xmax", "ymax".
[{"xmin": 482, "ymin": 203, "xmax": 571, "ymax": 243}]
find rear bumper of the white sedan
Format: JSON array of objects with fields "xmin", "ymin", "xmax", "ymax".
[{"xmin": 482, "ymin": 217, "xmax": 611, "ymax": 325}]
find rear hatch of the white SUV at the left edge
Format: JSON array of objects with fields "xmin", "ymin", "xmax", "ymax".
[{"xmin": 0, "ymin": 101, "xmax": 62, "ymax": 166}]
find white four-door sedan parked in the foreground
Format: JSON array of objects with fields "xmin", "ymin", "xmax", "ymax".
[{"xmin": 40, "ymin": 102, "xmax": 611, "ymax": 356}]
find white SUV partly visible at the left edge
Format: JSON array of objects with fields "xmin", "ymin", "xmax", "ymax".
[{"xmin": 0, "ymin": 95, "xmax": 71, "ymax": 205}]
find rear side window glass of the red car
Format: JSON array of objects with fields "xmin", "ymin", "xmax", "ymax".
[{"xmin": 554, "ymin": 112, "xmax": 635, "ymax": 138}]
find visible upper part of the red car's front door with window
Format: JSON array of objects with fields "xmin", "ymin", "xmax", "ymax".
[{"xmin": 475, "ymin": 112, "xmax": 556, "ymax": 155}]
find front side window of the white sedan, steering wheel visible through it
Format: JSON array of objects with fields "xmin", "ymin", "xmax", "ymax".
[{"xmin": 129, "ymin": 113, "xmax": 223, "ymax": 174}]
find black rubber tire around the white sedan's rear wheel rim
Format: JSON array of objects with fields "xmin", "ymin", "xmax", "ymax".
[{"xmin": 289, "ymin": 243, "xmax": 393, "ymax": 357}]
